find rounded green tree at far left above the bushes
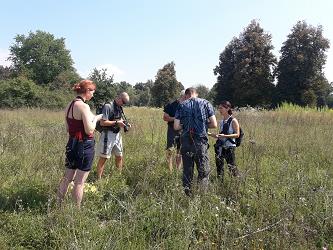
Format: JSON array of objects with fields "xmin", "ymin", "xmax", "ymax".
[{"xmin": 9, "ymin": 30, "xmax": 74, "ymax": 84}]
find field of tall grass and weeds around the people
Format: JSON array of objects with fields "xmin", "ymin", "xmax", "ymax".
[{"xmin": 0, "ymin": 106, "xmax": 333, "ymax": 249}]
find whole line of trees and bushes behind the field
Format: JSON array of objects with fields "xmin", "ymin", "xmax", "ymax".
[{"xmin": 0, "ymin": 20, "xmax": 333, "ymax": 108}]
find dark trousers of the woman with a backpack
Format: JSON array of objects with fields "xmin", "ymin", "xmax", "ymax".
[{"xmin": 215, "ymin": 147, "xmax": 238, "ymax": 179}]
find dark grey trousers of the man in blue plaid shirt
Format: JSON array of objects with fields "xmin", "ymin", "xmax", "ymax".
[{"xmin": 180, "ymin": 138, "xmax": 210, "ymax": 192}]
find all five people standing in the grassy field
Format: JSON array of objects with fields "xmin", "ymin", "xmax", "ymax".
[{"xmin": 57, "ymin": 80, "xmax": 240, "ymax": 207}]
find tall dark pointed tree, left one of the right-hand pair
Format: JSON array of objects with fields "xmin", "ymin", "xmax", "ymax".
[{"xmin": 214, "ymin": 20, "xmax": 276, "ymax": 106}]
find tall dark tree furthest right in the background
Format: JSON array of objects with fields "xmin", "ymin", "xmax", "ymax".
[{"xmin": 277, "ymin": 21, "xmax": 330, "ymax": 106}]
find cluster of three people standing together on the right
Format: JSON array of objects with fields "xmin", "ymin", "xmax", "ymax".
[{"xmin": 163, "ymin": 88, "xmax": 240, "ymax": 196}]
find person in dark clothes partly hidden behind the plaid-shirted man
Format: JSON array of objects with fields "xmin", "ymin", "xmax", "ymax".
[{"xmin": 163, "ymin": 90, "xmax": 185, "ymax": 172}]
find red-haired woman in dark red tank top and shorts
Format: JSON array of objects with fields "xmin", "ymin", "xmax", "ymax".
[{"xmin": 57, "ymin": 80, "xmax": 102, "ymax": 207}]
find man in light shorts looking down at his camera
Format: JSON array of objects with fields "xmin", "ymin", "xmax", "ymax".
[{"xmin": 97, "ymin": 92, "xmax": 131, "ymax": 179}]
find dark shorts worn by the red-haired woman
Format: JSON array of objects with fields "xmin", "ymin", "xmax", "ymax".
[{"xmin": 65, "ymin": 138, "xmax": 95, "ymax": 171}]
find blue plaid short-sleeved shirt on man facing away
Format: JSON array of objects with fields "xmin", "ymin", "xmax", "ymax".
[{"xmin": 175, "ymin": 98, "xmax": 215, "ymax": 137}]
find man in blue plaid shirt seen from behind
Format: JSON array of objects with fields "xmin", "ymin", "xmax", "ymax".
[{"xmin": 174, "ymin": 88, "xmax": 217, "ymax": 195}]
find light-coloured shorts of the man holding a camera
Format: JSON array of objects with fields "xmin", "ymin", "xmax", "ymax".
[{"xmin": 99, "ymin": 130, "xmax": 123, "ymax": 158}]
